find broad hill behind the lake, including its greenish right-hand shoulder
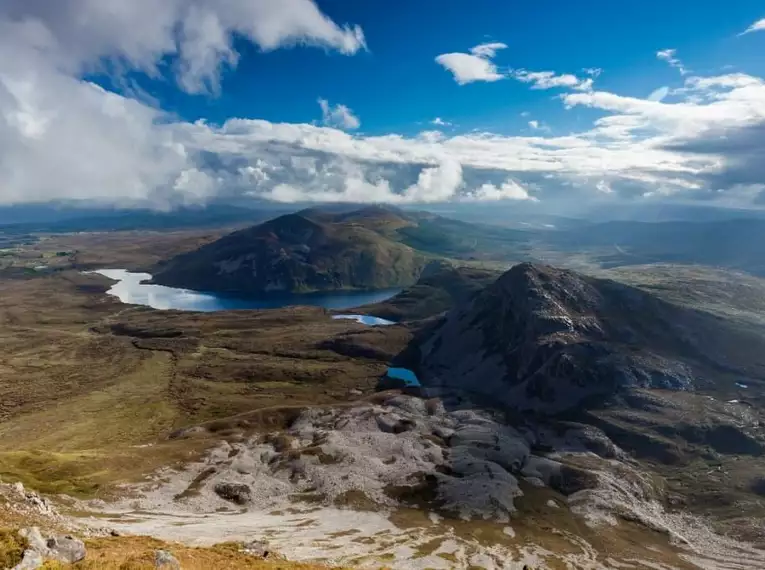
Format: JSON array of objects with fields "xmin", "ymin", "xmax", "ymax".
[{"xmin": 149, "ymin": 206, "xmax": 514, "ymax": 294}]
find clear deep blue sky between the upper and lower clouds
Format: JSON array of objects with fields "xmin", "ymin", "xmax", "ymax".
[{"xmin": 106, "ymin": 0, "xmax": 765, "ymax": 134}]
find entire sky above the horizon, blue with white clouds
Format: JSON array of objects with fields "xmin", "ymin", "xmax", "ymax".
[{"xmin": 0, "ymin": 0, "xmax": 765, "ymax": 209}]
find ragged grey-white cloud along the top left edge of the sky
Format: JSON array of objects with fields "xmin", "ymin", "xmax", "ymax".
[{"xmin": 0, "ymin": 0, "xmax": 366, "ymax": 93}]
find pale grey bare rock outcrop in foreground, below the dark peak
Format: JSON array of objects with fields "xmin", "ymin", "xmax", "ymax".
[{"xmin": 119, "ymin": 394, "xmax": 623, "ymax": 520}]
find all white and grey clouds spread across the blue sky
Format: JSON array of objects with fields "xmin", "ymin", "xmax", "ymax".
[{"xmin": 0, "ymin": 0, "xmax": 765, "ymax": 207}]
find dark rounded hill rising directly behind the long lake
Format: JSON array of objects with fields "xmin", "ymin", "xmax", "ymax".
[{"xmin": 154, "ymin": 208, "xmax": 427, "ymax": 294}]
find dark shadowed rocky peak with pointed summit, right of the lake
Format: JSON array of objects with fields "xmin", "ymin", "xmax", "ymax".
[{"xmin": 416, "ymin": 263, "xmax": 765, "ymax": 413}]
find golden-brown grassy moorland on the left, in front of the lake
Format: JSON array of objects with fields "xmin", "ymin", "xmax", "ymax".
[{"xmin": 0, "ymin": 234, "xmax": 409, "ymax": 497}]
